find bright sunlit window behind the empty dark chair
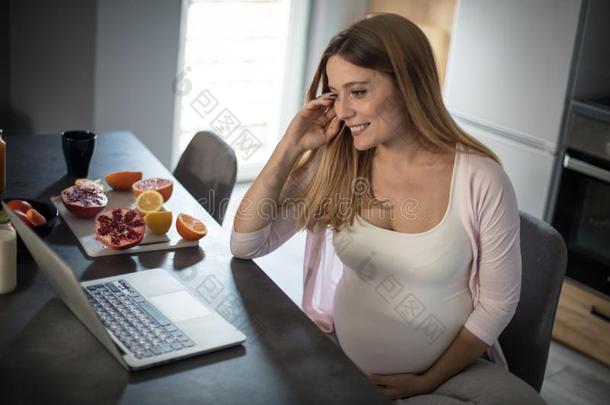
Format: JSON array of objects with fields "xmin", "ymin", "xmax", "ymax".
[{"xmin": 173, "ymin": 0, "xmax": 309, "ymax": 180}]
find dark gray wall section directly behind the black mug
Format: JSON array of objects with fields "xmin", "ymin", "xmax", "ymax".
[{"xmin": 10, "ymin": 0, "xmax": 96, "ymax": 133}]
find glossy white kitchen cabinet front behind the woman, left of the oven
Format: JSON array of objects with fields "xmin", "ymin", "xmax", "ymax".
[{"xmin": 444, "ymin": 0, "xmax": 581, "ymax": 219}]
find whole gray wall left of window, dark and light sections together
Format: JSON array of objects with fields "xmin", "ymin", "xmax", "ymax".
[{"xmin": 0, "ymin": 0, "xmax": 182, "ymax": 167}]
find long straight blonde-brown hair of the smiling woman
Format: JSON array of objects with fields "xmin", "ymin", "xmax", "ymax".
[{"xmin": 282, "ymin": 14, "xmax": 499, "ymax": 230}]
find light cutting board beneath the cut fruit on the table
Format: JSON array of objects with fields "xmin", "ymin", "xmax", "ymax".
[{"xmin": 51, "ymin": 191, "xmax": 200, "ymax": 257}]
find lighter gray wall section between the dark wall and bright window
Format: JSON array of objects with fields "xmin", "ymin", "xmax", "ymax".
[{"xmin": 93, "ymin": 0, "xmax": 182, "ymax": 168}]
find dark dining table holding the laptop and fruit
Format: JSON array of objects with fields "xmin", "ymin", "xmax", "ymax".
[{"xmin": 0, "ymin": 131, "xmax": 391, "ymax": 404}]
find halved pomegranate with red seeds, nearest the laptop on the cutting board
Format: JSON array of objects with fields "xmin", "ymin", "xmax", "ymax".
[{"xmin": 95, "ymin": 208, "xmax": 144, "ymax": 250}]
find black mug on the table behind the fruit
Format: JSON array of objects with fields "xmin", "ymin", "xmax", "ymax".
[{"xmin": 61, "ymin": 131, "xmax": 97, "ymax": 177}]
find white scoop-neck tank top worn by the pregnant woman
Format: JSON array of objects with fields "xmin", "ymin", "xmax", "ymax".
[{"xmin": 333, "ymin": 153, "xmax": 473, "ymax": 374}]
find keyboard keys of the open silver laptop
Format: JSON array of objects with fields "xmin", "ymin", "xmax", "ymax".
[{"xmin": 83, "ymin": 280, "xmax": 195, "ymax": 359}]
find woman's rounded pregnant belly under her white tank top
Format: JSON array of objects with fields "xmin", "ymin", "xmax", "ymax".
[{"xmin": 334, "ymin": 280, "xmax": 472, "ymax": 374}]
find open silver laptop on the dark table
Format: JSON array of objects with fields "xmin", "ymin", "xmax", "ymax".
[{"xmin": 2, "ymin": 202, "xmax": 246, "ymax": 370}]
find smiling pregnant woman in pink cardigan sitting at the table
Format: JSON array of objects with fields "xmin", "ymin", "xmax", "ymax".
[{"xmin": 231, "ymin": 14, "xmax": 543, "ymax": 404}]
